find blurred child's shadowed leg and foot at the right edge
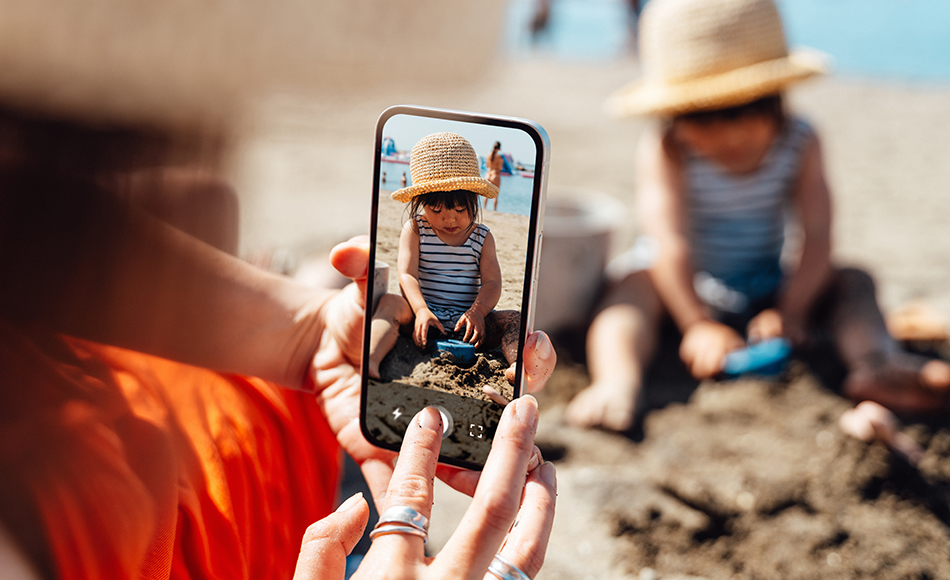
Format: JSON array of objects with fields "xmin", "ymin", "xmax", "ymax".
[{"xmin": 827, "ymin": 269, "xmax": 950, "ymax": 412}]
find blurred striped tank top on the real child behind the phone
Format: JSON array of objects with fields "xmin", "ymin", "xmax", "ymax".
[{"xmin": 684, "ymin": 118, "xmax": 813, "ymax": 310}]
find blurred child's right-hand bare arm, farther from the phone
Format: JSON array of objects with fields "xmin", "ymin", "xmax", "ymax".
[{"xmin": 779, "ymin": 137, "xmax": 831, "ymax": 340}]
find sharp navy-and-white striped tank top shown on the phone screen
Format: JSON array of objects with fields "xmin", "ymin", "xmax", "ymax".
[{"xmin": 414, "ymin": 215, "xmax": 489, "ymax": 330}]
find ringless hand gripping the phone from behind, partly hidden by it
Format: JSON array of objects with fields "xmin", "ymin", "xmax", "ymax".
[{"xmin": 310, "ymin": 237, "xmax": 557, "ymax": 498}]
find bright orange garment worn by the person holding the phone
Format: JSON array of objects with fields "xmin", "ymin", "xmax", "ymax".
[{"xmin": 0, "ymin": 321, "xmax": 339, "ymax": 580}]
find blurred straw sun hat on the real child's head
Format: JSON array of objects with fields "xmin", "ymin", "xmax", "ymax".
[{"xmin": 605, "ymin": 0, "xmax": 826, "ymax": 116}]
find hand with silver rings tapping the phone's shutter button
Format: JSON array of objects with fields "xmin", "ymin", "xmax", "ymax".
[{"xmin": 294, "ymin": 397, "xmax": 557, "ymax": 580}]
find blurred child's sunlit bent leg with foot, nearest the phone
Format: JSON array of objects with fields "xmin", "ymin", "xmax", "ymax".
[{"xmin": 566, "ymin": 271, "xmax": 663, "ymax": 431}]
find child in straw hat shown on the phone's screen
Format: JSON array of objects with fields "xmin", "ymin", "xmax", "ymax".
[{"xmin": 369, "ymin": 133, "xmax": 521, "ymax": 380}]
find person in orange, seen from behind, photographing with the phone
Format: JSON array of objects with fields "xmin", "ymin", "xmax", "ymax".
[{"xmin": 0, "ymin": 0, "xmax": 555, "ymax": 580}]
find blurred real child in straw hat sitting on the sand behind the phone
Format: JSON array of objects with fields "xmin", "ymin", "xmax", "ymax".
[{"xmin": 566, "ymin": 0, "xmax": 950, "ymax": 431}]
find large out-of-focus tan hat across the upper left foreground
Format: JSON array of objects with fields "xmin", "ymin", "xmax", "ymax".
[{"xmin": 0, "ymin": 0, "xmax": 504, "ymax": 127}]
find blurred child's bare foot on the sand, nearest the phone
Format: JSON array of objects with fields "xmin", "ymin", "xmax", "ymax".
[{"xmin": 565, "ymin": 382, "xmax": 643, "ymax": 433}]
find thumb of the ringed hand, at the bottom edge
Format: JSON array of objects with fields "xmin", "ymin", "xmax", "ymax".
[{"xmin": 294, "ymin": 493, "xmax": 369, "ymax": 580}]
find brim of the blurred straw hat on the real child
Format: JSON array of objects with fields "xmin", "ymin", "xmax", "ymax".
[{"xmin": 604, "ymin": 50, "xmax": 828, "ymax": 117}]
